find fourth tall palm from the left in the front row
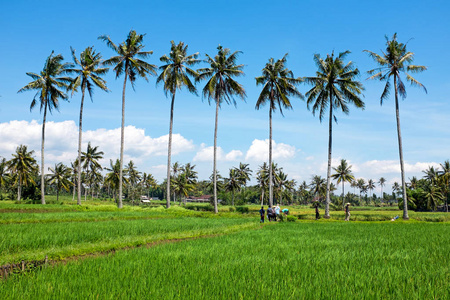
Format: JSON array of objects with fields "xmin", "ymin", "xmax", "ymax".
[{"xmin": 156, "ymin": 41, "xmax": 200, "ymax": 208}]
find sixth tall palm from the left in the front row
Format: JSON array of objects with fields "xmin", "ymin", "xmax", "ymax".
[{"xmin": 255, "ymin": 54, "xmax": 303, "ymax": 209}]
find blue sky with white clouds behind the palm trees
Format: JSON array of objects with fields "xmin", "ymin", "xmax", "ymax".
[{"xmin": 0, "ymin": 1, "xmax": 450, "ymax": 191}]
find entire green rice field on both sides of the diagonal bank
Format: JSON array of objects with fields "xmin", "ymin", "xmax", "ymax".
[{"xmin": 0, "ymin": 203, "xmax": 450, "ymax": 299}]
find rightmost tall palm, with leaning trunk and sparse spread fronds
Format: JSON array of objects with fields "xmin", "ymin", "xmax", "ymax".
[{"xmin": 364, "ymin": 33, "xmax": 427, "ymax": 220}]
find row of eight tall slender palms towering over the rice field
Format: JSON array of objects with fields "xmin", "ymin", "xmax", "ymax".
[{"xmin": 19, "ymin": 30, "xmax": 426, "ymax": 219}]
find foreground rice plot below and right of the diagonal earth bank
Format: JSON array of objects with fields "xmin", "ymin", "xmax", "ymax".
[{"xmin": 0, "ymin": 220, "xmax": 450, "ymax": 299}]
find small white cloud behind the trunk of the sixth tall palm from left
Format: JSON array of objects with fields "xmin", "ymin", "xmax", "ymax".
[{"xmin": 245, "ymin": 139, "xmax": 296, "ymax": 162}]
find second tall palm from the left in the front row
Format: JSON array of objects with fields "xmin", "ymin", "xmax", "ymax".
[{"xmin": 69, "ymin": 47, "xmax": 108, "ymax": 205}]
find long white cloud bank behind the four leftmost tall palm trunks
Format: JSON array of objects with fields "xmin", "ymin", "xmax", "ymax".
[{"xmin": 0, "ymin": 120, "xmax": 195, "ymax": 169}]
